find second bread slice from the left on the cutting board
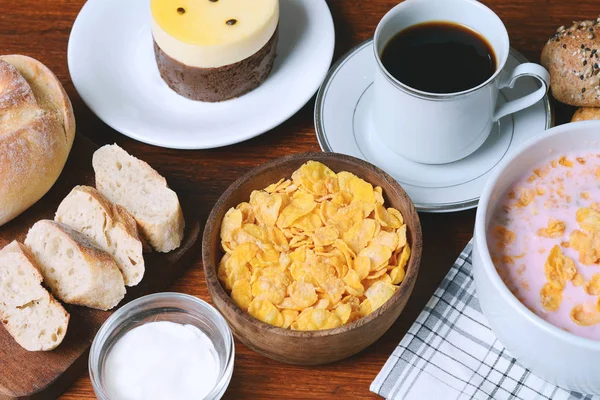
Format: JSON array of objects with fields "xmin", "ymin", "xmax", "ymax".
[{"xmin": 25, "ymin": 220, "xmax": 125, "ymax": 310}]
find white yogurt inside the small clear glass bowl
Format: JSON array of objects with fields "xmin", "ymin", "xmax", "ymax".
[{"xmin": 104, "ymin": 321, "xmax": 219, "ymax": 400}]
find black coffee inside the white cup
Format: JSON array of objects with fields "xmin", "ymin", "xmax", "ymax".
[{"xmin": 381, "ymin": 21, "xmax": 496, "ymax": 93}]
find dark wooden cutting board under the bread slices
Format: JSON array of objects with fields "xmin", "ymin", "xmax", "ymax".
[{"xmin": 0, "ymin": 135, "xmax": 200, "ymax": 400}]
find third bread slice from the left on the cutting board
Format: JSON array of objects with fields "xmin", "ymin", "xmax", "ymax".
[{"xmin": 54, "ymin": 186, "xmax": 144, "ymax": 286}]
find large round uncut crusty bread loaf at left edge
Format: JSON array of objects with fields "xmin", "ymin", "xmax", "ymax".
[{"xmin": 0, "ymin": 55, "xmax": 75, "ymax": 225}]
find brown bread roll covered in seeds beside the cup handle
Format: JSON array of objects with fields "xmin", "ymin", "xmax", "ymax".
[{"xmin": 541, "ymin": 18, "xmax": 600, "ymax": 107}]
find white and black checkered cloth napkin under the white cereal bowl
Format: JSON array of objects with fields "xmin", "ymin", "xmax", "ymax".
[{"xmin": 371, "ymin": 242, "xmax": 600, "ymax": 400}]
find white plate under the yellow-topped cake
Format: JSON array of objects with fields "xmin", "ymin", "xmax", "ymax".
[{"xmin": 68, "ymin": 0, "xmax": 335, "ymax": 149}]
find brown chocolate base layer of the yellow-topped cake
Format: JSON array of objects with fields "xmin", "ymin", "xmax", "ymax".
[{"xmin": 154, "ymin": 29, "xmax": 279, "ymax": 102}]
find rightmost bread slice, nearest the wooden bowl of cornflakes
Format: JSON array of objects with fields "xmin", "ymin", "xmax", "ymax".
[{"xmin": 92, "ymin": 144, "xmax": 184, "ymax": 253}]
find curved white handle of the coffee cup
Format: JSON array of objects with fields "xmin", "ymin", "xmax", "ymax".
[{"xmin": 494, "ymin": 63, "xmax": 550, "ymax": 122}]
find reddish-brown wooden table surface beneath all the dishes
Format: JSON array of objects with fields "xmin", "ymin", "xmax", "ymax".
[{"xmin": 0, "ymin": 0, "xmax": 600, "ymax": 400}]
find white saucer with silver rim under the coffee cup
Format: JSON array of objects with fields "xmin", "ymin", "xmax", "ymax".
[{"xmin": 315, "ymin": 39, "xmax": 553, "ymax": 212}]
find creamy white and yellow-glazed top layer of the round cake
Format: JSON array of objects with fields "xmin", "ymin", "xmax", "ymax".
[{"xmin": 150, "ymin": 0, "xmax": 279, "ymax": 68}]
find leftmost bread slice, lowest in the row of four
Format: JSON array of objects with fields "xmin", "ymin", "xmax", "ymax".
[{"xmin": 0, "ymin": 241, "xmax": 69, "ymax": 351}]
